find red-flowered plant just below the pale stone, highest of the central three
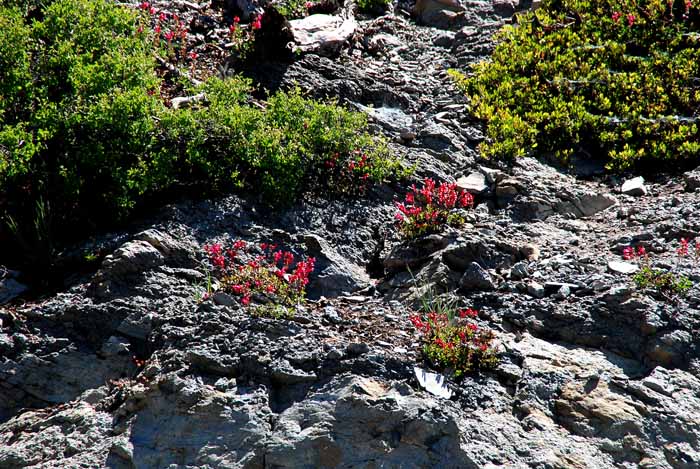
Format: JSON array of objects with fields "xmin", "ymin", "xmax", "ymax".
[{"xmin": 396, "ymin": 178, "xmax": 474, "ymax": 239}]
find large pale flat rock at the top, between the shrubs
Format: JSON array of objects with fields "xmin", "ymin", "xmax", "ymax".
[{"xmin": 289, "ymin": 14, "xmax": 357, "ymax": 56}]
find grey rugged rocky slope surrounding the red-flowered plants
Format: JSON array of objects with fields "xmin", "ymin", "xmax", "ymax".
[{"xmin": 0, "ymin": 1, "xmax": 700, "ymax": 469}]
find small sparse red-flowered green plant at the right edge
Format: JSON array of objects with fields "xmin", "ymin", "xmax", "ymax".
[{"xmin": 622, "ymin": 238, "xmax": 700, "ymax": 299}]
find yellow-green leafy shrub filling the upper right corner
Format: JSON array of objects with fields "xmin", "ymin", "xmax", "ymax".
[{"xmin": 451, "ymin": 0, "xmax": 700, "ymax": 169}]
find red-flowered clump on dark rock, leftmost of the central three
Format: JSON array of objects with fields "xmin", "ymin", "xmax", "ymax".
[{"xmin": 204, "ymin": 240, "xmax": 316, "ymax": 317}]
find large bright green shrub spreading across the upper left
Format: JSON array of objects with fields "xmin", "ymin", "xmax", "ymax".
[{"xmin": 0, "ymin": 0, "xmax": 400, "ymax": 268}]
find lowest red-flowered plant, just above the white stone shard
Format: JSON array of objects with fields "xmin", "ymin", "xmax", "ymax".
[{"xmin": 409, "ymin": 308, "xmax": 498, "ymax": 378}]
